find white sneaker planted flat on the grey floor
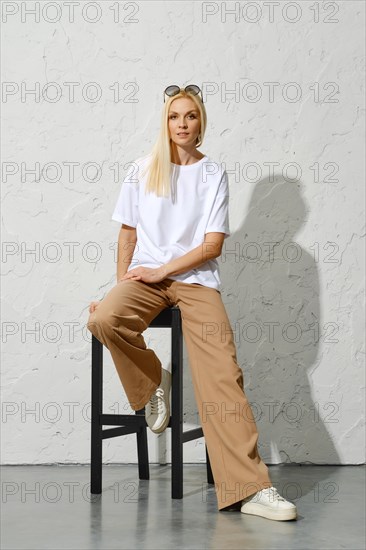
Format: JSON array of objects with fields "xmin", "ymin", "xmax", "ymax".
[{"xmin": 240, "ymin": 487, "xmax": 297, "ymax": 521}]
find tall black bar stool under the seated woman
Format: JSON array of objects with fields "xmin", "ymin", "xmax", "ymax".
[{"xmin": 90, "ymin": 306, "xmax": 214, "ymax": 498}]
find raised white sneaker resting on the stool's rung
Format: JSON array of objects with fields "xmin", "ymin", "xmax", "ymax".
[{"xmin": 145, "ymin": 368, "xmax": 172, "ymax": 433}]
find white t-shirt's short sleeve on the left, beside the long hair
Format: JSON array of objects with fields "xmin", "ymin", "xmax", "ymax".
[{"xmin": 112, "ymin": 165, "xmax": 138, "ymax": 227}]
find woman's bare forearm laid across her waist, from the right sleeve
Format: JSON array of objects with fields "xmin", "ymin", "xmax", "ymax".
[{"xmin": 159, "ymin": 233, "xmax": 225, "ymax": 278}]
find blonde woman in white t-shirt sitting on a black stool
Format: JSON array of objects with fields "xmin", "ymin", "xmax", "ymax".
[{"xmin": 87, "ymin": 85, "xmax": 296, "ymax": 520}]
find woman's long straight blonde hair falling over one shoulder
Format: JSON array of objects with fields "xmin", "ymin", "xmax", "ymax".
[{"xmin": 143, "ymin": 90, "xmax": 207, "ymax": 197}]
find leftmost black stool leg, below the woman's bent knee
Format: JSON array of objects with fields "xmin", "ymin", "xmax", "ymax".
[{"xmin": 90, "ymin": 335, "xmax": 103, "ymax": 494}]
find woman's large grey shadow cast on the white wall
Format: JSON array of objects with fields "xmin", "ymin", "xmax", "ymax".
[{"xmin": 220, "ymin": 175, "xmax": 340, "ymax": 474}]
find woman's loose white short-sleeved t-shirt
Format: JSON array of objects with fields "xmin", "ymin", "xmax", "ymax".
[{"xmin": 112, "ymin": 155, "xmax": 230, "ymax": 290}]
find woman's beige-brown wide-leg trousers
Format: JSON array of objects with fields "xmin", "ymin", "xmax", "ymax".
[{"xmin": 87, "ymin": 278, "xmax": 272, "ymax": 510}]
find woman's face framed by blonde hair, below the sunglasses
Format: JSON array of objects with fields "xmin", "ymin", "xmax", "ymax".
[{"xmin": 168, "ymin": 97, "xmax": 201, "ymax": 147}]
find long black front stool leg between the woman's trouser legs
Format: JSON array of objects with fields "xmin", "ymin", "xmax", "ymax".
[{"xmin": 171, "ymin": 310, "xmax": 183, "ymax": 498}]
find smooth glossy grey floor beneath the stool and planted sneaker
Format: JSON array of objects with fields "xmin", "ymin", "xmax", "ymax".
[{"xmin": 1, "ymin": 464, "xmax": 365, "ymax": 550}]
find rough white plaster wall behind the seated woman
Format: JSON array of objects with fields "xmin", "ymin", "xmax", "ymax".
[{"xmin": 2, "ymin": 1, "xmax": 365, "ymax": 464}]
